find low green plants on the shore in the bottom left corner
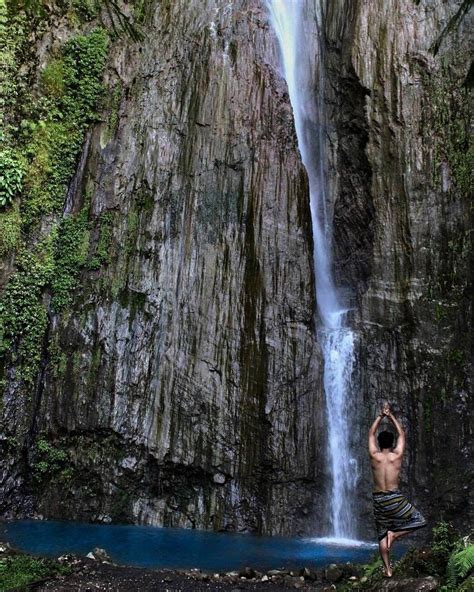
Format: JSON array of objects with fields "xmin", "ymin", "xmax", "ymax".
[{"xmin": 0, "ymin": 555, "xmax": 71, "ymax": 592}]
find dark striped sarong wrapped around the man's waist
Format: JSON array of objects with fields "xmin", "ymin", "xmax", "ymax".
[{"xmin": 372, "ymin": 489, "xmax": 427, "ymax": 541}]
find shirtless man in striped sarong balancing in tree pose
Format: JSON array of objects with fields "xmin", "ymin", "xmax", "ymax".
[{"xmin": 369, "ymin": 405, "xmax": 426, "ymax": 578}]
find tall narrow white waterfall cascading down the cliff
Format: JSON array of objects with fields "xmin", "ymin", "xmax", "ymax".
[{"xmin": 267, "ymin": 0, "xmax": 358, "ymax": 539}]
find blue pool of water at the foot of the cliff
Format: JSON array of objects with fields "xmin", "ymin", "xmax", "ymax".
[{"xmin": 0, "ymin": 520, "xmax": 400, "ymax": 571}]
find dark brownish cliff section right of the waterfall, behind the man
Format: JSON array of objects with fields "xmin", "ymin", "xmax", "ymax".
[{"xmin": 325, "ymin": 0, "xmax": 473, "ymax": 526}]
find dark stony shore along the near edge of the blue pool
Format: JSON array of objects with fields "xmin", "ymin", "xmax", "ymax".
[{"xmin": 0, "ymin": 543, "xmax": 452, "ymax": 592}]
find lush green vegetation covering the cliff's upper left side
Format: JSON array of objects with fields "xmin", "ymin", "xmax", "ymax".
[{"xmin": 0, "ymin": 0, "xmax": 115, "ymax": 385}]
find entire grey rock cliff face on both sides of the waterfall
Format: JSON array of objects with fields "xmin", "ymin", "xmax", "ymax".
[{"xmin": 0, "ymin": 0, "xmax": 472, "ymax": 534}]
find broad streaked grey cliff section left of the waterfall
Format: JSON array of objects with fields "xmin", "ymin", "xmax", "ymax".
[{"xmin": 0, "ymin": 0, "xmax": 324, "ymax": 532}]
